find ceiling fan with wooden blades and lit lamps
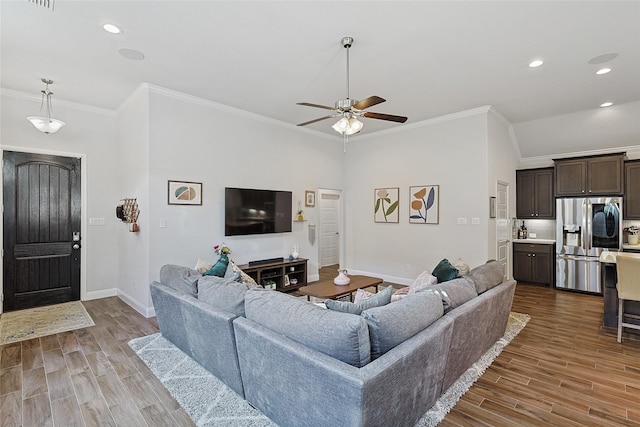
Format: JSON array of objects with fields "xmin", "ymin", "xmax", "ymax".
[{"xmin": 297, "ymin": 37, "xmax": 407, "ymax": 142}]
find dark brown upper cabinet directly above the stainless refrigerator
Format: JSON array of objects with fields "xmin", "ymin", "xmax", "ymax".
[{"xmin": 555, "ymin": 154, "xmax": 624, "ymax": 197}]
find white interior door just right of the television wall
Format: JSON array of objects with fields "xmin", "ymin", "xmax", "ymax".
[{"xmin": 318, "ymin": 189, "xmax": 341, "ymax": 267}]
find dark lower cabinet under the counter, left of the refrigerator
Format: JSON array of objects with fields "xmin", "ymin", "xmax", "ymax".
[{"xmin": 513, "ymin": 243, "xmax": 555, "ymax": 287}]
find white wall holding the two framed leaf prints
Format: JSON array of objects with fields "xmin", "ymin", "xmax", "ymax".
[{"xmin": 344, "ymin": 109, "xmax": 488, "ymax": 283}]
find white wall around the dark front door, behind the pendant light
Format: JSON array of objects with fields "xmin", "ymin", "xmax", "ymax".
[{"xmin": 0, "ymin": 89, "xmax": 119, "ymax": 310}]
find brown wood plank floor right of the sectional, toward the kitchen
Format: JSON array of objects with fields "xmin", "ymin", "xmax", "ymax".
[{"xmin": 441, "ymin": 284, "xmax": 640, "ymax": 426}]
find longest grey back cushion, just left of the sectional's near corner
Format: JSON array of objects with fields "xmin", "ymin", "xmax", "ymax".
[{"xmin": 245, "ymin": 288, "xmax": 371, "ymax": 368}]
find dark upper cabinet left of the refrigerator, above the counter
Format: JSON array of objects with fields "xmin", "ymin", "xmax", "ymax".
[{"xmin": 516, "ymin": 168, "xmax": 556, "ymax": 219}]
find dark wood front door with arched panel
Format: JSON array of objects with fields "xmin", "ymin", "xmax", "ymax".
[{"xmin": 3, "ymin": 151, "xmax": 80, "ymax": 311}]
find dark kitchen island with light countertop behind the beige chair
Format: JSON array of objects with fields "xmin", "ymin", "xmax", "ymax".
[{"xmin": 600, "ymin": 252, "xmax": 640, "ymax": 328}]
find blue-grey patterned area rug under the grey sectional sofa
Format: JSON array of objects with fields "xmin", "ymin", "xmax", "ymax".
[{"xmin": 129, "ymin": 312, "xmax": 530, "ymax": 427}]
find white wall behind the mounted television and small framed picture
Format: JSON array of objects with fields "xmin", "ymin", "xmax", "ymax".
[{"xmin": 141, "ymin": 87, "xmax": 343, "ymax": 300}]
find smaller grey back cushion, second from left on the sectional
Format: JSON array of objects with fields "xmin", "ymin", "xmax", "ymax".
[{"xmin": 198, "ymin": 276, "xmax": 255, "ymax": 316}]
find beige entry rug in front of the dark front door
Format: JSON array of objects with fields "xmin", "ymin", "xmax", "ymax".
[{"xmin": 0, "ymin": 301, "xmax": 95, "ymax": 345}]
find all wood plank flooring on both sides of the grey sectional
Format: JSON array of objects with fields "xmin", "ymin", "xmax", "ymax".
[{"xmin": 0, "ymin": 280, "xmax": 640, "ymax": 427}]
